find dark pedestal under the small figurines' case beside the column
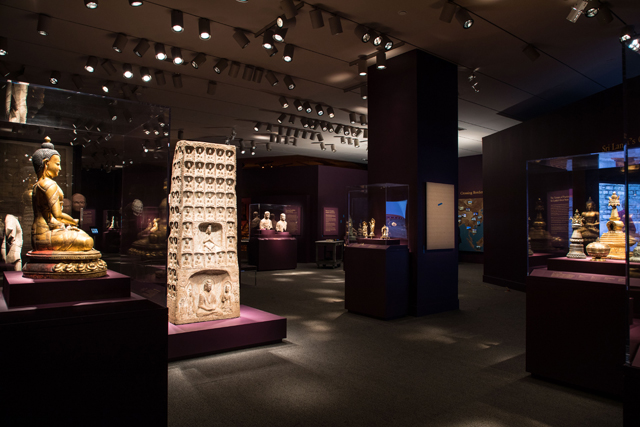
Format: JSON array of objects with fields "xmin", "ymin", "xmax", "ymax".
[{"xmin": 344, "ymin": 244, "xmax": 409, "ymax": 319}]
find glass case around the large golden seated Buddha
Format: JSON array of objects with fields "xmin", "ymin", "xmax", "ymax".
[{"xmin": 0, "ymin": 80, "xmax": 171, "ymax": 283}]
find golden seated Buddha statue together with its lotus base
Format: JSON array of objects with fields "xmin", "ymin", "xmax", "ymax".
[{"xmin": 23, "ymin": 137, "xmax": 107, "ymax": 278}]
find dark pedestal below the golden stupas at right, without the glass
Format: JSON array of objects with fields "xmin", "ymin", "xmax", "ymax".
[{"xmin": 526, "ymin": 268, "xmax": 639, "ymax": 396}]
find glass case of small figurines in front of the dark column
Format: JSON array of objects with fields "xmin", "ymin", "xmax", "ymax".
[{"xmin": 345, "ymin": 184, "xmax": 409, "ymax": 244}]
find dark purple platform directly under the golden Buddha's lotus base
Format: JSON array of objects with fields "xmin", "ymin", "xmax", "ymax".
[{"xmin": 2, "ymin": 270, "xmax": 131, "ymax": 307}]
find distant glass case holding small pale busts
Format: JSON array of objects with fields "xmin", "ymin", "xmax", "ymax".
[{"xmin": 249, "ymin": 203, "xmax": 302, "ymax": 237}]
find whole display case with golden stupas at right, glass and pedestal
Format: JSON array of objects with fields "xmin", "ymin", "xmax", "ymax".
[{"xmin": 524, "ymin": 148, "xmax": 640, "ymax": 395}]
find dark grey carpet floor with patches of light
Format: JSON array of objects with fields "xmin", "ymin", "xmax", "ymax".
[{"xmin": 169, "ymin": 264, "xmax": 622, "ymax": 427}]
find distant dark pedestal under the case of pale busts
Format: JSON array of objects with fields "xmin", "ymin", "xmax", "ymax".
[{"xmin": 249, "ymin": 236, "xmax": 298, "ymax": 271}]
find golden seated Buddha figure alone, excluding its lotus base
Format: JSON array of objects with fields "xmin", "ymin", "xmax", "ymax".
[{"xmin": 31, "ymin": 137, "xmax": 93, "ymax": 251}]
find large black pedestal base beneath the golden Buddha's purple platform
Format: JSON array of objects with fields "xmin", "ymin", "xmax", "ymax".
[{"xmin": 0, "ymin": 294, "xmax": 167, "ymax": 426}]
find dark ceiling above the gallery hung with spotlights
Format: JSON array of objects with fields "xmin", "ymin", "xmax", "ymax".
[{"xmin": 0, "ymin": 0, "xmax": 640, "ymax": 163}]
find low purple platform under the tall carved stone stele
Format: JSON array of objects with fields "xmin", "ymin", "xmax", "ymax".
[{"xmin": 169, "ymin": 305, "xmax": 287, "ymax": 360}]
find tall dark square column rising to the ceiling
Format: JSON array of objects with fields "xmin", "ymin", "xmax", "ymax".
[{"xmin": 368, "ymin": 50, "xmax": 458, "ymax": 316}]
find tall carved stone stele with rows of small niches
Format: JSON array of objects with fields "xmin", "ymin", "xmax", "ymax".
[{"xmin": 167, "ymin": 141, "xmax": 240, "ymax": 325}]
